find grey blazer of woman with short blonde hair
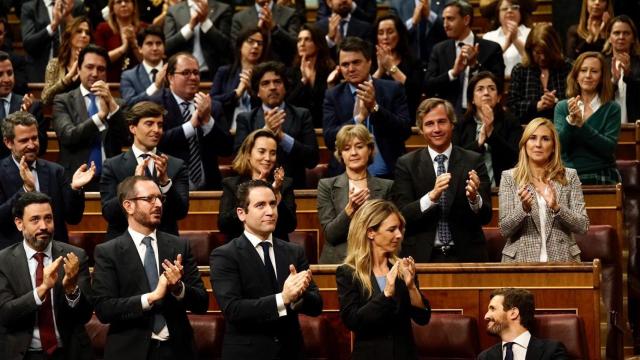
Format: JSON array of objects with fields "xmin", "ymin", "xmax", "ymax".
[{"xmin": 318, "ymin": 172, "xmax": 393, "ymax": 264}]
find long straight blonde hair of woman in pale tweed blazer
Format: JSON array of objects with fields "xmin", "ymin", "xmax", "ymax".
[{"xmin": 513, "ymin": 118, "xmax": 567, "ymax": 187}]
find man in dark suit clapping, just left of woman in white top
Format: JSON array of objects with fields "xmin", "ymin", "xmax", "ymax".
[{"xmin": 425, "ymin": 0, "xmax": 504, "ymax": 115}]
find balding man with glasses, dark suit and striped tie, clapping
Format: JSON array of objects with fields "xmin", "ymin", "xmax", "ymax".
[{"xmin": 151, "ymin": 53, "xmax": 233, "ymax": 190}]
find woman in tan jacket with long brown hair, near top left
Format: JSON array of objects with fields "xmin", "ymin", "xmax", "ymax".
[{"xmin": 41, "ymin": 16, "xmax": 91, "ymax": 105}]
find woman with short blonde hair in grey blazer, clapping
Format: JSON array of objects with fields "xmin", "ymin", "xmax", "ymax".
[{"xmin": 318, "ymin": 125, "xmax": 393, "ymax": 264}]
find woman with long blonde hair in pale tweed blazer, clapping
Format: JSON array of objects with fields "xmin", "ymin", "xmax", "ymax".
[{"xmin": 498, "ymin": 118, "xmax": 589, "ymax": 262}]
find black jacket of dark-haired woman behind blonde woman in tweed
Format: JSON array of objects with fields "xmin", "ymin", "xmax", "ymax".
[{"xmin": 453, "ymin": 109, "xmax": 522, "ymax": 187}]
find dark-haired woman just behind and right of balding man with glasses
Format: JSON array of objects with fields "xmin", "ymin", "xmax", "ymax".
[{"xmin": 209, "ymin": 27, "xmax": 269, "ymax": 130}]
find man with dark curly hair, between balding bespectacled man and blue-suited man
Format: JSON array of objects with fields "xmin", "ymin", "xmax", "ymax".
[{"xmin": 234, "ymin": 61, "xmax": 319, "ymax": 189}]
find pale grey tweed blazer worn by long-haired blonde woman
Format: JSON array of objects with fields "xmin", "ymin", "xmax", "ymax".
[{"xmin": 498, "ymin": 168, "xmax": 589, "ymax": 262}]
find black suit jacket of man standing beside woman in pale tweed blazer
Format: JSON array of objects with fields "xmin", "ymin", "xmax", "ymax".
[{"xmin": 392, "ymin": 146, "xmax": 491, "ymax": 262}]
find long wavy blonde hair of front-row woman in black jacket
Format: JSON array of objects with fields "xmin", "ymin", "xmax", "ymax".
[{"xmin": 344, "ymin": 199, "xmax": 406, "ymax": 298}]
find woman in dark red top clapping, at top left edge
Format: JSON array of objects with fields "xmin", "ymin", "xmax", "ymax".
[{"xmin": 95, "ymin": 0, "xmax": 147, "ymax": 83}]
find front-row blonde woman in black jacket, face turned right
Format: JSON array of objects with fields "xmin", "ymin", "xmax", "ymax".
[{"xmin": 336, "ymin": 199, "xmax": 431, "ymax": 360}]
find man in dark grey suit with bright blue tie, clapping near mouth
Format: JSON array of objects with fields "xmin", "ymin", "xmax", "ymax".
[{"xmin": 53, "ymin": 45, "xmax": 127, "ymax": 191}]
